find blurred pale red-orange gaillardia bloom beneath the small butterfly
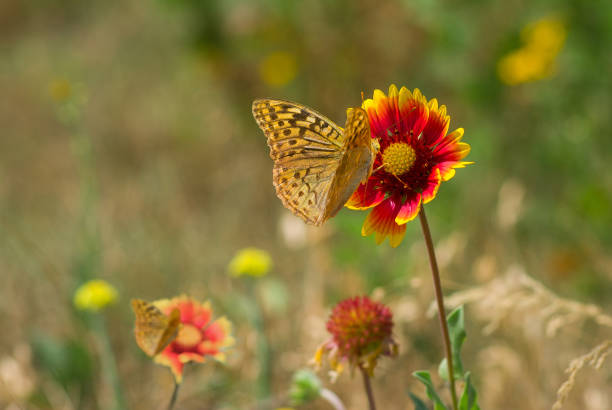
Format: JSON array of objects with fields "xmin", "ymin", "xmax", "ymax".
[{"xmin": 153, "ymin": 295, "xmax": 234, "ymax": 383}]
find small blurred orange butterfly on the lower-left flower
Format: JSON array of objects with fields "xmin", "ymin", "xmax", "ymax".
[{"xmin": 132, "ymin": 299, "xmax": 181, "ymax": 357}]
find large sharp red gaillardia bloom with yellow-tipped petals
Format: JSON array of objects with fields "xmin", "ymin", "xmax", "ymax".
[{"xmin": 346, "ymin": 85, "xmax": 471, "ymax": 247}]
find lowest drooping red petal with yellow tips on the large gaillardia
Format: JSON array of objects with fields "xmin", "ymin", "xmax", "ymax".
[{"xmin": 361, "ymin": 196, "xmax": 406, "ymax": 248}]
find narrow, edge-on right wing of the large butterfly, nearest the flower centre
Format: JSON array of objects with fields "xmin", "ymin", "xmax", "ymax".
[{"xmin": 325, "ymin": 108, "xmax": 377, "ymax": 219}]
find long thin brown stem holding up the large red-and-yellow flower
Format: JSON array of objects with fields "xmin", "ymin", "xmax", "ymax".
[{"xmin": 419, "ymin": 205, "xmax": 457, "ymax": 410}]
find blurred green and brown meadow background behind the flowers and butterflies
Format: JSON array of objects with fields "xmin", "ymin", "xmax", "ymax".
[{"xmin": 0, "ymin": 0, "xmax": 612, "ymax": 410}]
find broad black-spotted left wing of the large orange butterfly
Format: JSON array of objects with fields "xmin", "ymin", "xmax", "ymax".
[{"xmin": 253, "ymin": 99, "xmax": 348, "ymax": 226}]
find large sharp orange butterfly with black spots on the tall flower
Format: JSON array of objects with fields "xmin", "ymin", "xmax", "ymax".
[{"xmin": 253, "ymin": 99, "xmax": 378, "ymax": 226}]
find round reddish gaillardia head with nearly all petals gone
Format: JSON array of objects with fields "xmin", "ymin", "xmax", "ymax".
[{"xmin": 314, "ymin": 296, "xmax": 397, "ymax": 378}]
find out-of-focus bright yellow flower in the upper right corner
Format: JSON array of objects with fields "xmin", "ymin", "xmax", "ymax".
[{"xmin": 497, "ymin": 17, "xmax": 567, "ymax": 85}]
